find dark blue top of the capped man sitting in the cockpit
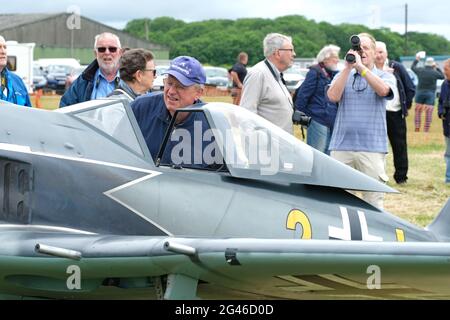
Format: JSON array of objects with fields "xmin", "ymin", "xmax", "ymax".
[{"xmin": 131, "ymin": 93, "xmax": 211, "ymax": 168}]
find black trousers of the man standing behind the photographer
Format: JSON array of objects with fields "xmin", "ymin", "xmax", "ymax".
[{"xmin": 386, "ymin": 110, "xmax": 408, "ymax": 183}]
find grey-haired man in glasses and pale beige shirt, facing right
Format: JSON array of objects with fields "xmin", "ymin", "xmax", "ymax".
[{"xmin": 240, "ymin": 33, "xmax": 295, "ymax": 134}]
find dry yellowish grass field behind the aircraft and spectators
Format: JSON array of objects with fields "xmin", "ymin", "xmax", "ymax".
[{"xmin": 32, "ymin": 96, "xmax": 450, "ymax": 226}]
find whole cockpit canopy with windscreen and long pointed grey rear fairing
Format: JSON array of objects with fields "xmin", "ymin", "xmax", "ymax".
[{"xmin": 54, "ymin": 99, "xmax": 393, "ymax": 192}]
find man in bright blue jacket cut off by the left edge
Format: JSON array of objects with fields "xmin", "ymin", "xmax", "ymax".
[{"xmin": 0, "ymin": 36, "xmax": 31, "ymax": 107}]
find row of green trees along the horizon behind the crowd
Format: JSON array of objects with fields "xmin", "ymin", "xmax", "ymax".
[{"xmin": 124, "ymin": 15, "xmax": 450, "ymax": 67}]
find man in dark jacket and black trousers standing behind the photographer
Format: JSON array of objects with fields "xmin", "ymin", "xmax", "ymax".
[{"xmin": 375, "ymin": 41, "xmax": 416, "ymax": 184}]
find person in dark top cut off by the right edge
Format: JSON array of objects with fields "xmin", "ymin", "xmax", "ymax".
[{"xmin": 438, "ymin": 59, "xmax": 450, "ymax": 183}]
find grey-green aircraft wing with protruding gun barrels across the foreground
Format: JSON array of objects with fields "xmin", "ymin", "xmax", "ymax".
[{"xmin": 0, "ymin": 231, "xmax": 450, "ymax": 299}]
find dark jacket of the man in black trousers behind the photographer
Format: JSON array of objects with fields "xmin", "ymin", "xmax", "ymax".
[{"xmin": 389, "ymin": 61, "xmax": 416, "ymax": 117}]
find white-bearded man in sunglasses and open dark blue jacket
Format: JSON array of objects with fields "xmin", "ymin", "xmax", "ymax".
[{"xmin": 59, "ymin": 32, "xmax": 122, "ymax": 107}]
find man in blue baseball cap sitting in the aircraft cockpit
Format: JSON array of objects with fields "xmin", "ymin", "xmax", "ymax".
[{"xmin": 131, "ymin": 56, "xmax": 214, "ymax": 167}]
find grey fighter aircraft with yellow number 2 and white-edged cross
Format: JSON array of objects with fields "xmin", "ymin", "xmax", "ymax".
[{"xmin": 0, "ymin": 99, "xmax": 450, "ymax": 299}]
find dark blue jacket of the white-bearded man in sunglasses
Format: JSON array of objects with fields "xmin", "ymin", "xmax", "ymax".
[{"xmin": 59, "ymin": 59, "xmax": 99, "ymax": 108}]
